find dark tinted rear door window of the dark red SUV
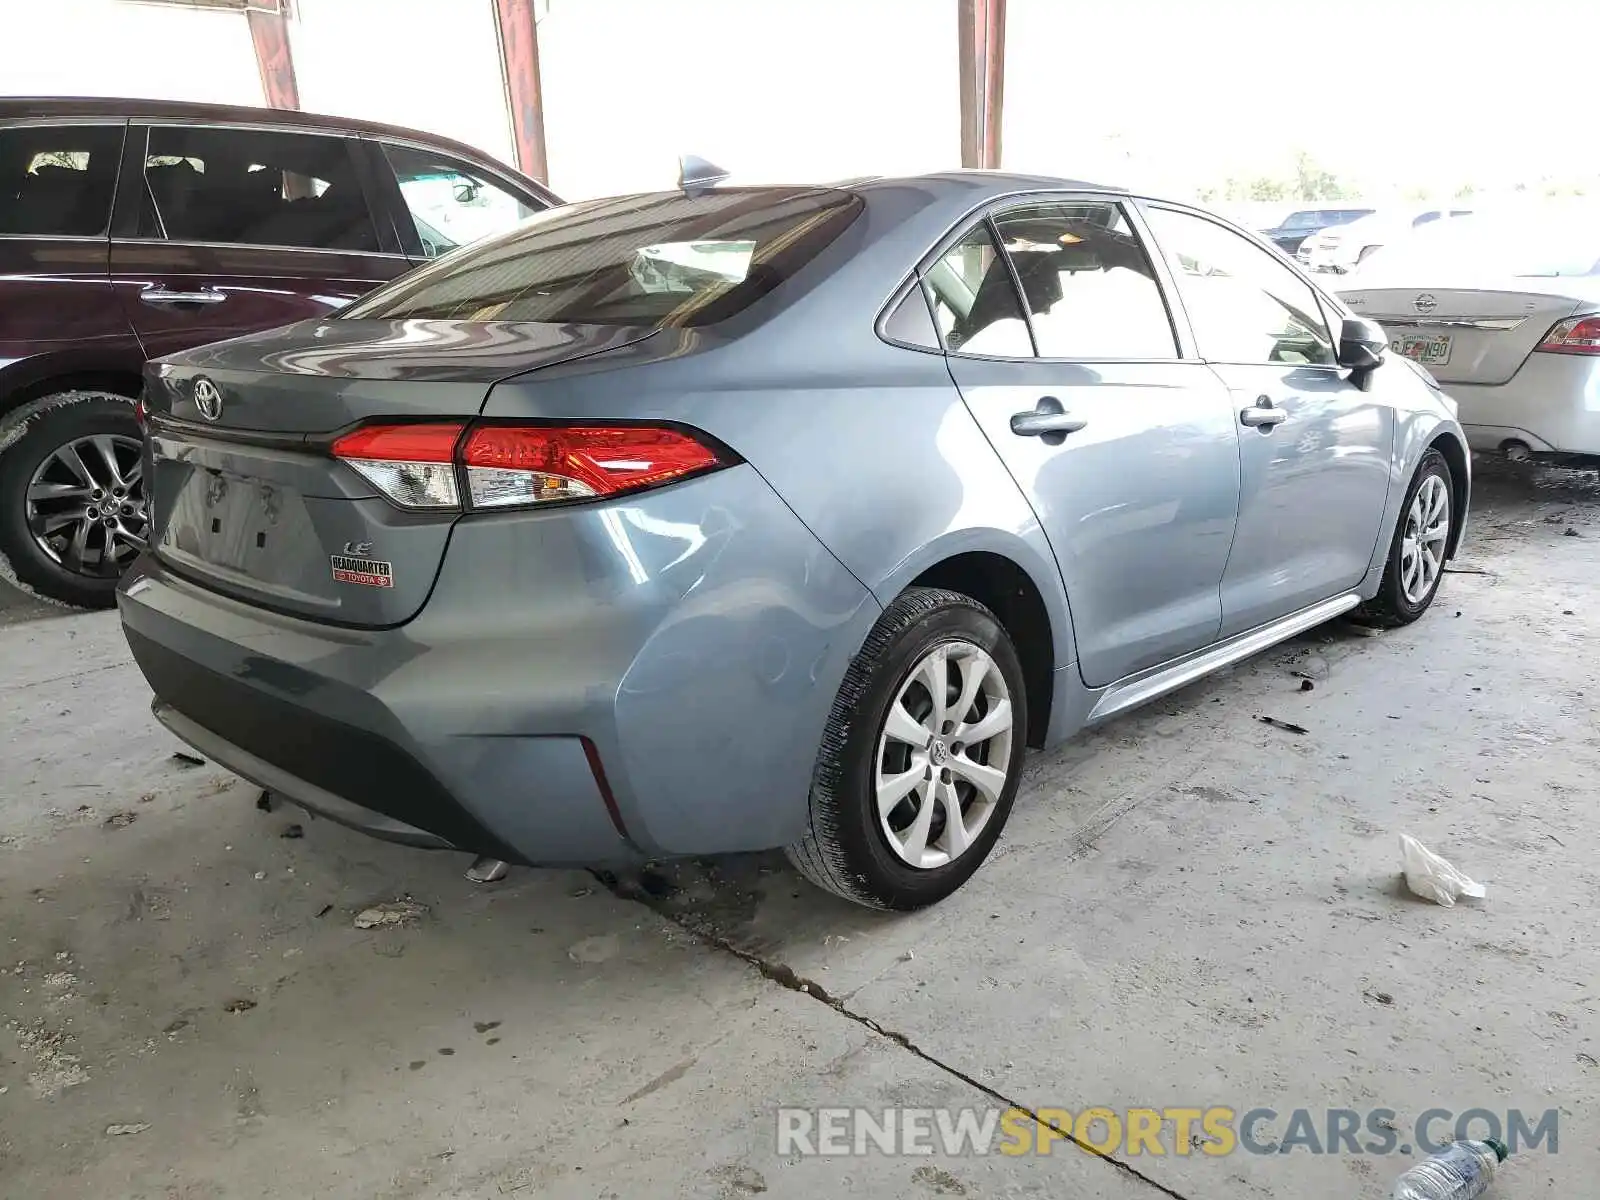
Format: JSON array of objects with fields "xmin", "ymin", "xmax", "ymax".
[{"xmin": 139, "ymin": 126, "xmax": 379, "ymax": 251}]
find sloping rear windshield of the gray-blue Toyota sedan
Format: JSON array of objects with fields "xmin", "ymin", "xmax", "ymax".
[{"xmin": 341, "ymin": 189, "xmax": 862, "ymax": 328}]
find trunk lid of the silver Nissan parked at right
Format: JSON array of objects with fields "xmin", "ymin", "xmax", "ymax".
[{"xmin": 1341, "ymin": 278, "xmax": 1600, "ymax": 386}]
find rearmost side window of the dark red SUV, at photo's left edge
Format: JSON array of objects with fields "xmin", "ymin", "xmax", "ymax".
[{"xmin": 0, "ymin": 125, "xmax": 123, "ymax": 237}]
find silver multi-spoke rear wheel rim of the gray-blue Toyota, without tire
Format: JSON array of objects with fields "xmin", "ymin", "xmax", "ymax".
[{"xmin": 874, "ymin": 642, "xmax": 1014, "ymax": 870}]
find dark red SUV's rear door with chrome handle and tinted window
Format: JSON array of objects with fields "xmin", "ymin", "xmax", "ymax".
[{"xmin": 110, "ymin": 125, "xmax": 410, "ymax": 358}]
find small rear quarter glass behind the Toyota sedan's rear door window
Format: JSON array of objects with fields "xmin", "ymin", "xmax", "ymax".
[{"xmin": 923, "ymin": 221, "xmax": 1034, "ymax": 358}]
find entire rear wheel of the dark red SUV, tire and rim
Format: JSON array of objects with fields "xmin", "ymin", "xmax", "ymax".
[{"xmin": 0, "ymin": 392, "xmax": 147, "ymax": 608}]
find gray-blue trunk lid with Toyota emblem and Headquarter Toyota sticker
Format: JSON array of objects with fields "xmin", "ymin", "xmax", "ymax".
[{"xmin": 146, "ymin": 320, "xmax": 651, "ymax": 627}]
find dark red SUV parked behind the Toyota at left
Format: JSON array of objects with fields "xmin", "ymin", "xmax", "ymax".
[{"xmin": 0, "ymin": 99, "xmax": 557, "ymax": 606}]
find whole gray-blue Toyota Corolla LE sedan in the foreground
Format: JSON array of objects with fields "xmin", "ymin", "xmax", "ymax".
[{"xmin": 120, "ymin": 173, "xmax": 1469, "ymax": 909}]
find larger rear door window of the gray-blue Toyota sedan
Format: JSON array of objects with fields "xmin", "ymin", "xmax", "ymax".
[{"xmin": 995, "ymin": 203, "xmax": 1178, "ymax": 358}]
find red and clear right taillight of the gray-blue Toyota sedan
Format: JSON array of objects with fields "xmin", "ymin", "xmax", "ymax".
[{"xmin": 333, "ymin": 424, "xmax": 723, "ymax": 509}]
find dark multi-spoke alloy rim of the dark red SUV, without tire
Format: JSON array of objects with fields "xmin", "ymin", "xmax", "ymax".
[{"xmin": 27, "ymin": 434, "xmax": 149, "ymax": 579}]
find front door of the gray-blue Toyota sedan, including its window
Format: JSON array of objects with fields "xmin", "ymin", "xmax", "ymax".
[{"xmin": 1146, "ymin": 205, "xmax": 1394, "ymax": 637}]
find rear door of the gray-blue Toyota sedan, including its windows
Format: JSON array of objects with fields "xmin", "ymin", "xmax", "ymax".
[{"xmin": 925, "ymin": 198, "xmax": 1238, "ymax": 686}]
